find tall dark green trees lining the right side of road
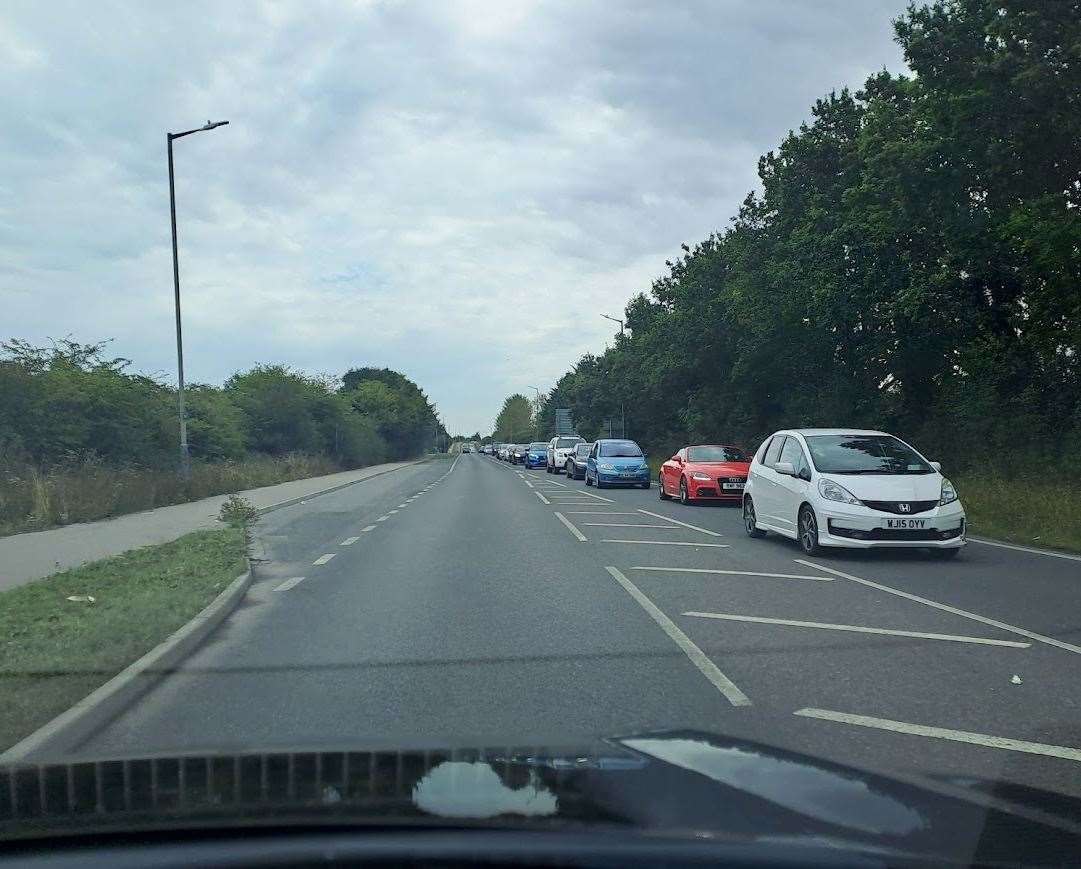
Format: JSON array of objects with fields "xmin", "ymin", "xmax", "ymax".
[{"xmin": 534, "ymin": 0, "xmax": 1081, "ymax": 476}]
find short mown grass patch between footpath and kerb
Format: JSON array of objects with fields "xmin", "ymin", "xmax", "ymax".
[{"xmin": 0, "ymin": 527, "xmax": 248, "ymax": 750}]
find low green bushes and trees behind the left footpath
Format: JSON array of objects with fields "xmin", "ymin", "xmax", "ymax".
[{"xmin": 0, "ymin": 339, "xmax": 446, "ymax": 470}]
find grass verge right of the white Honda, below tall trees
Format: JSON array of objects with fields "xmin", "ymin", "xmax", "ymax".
[{"xmin": 950, "ymin": 474, "xmax": 1081, "ymax": 552}]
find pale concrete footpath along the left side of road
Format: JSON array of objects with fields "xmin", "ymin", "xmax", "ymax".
[{"xmin": 0, "ymin": 462, "xmax": 415, "ymax": 591}]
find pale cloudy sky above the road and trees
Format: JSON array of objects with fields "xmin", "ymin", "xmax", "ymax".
[{"xmin": 0, "ymin": 0, "xmax": 906, "ymax": 432}]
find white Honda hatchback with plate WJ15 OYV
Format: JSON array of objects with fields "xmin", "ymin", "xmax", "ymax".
[{"xmin": 743, "ymin": 428, "xmax": 965, "ymax": 558}]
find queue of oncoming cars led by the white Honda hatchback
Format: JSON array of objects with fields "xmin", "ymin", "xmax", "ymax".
[{"xmin": 493, "ymin": 428, "xmax": 966, "ymax": 558}]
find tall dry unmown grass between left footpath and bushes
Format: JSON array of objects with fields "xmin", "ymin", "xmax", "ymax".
[{"xmin": 0, "ymin": 453, "xmax": 342, "ymax": 535}]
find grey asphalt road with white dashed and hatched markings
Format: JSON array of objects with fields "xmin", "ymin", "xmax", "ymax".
[{"xmin": 77, "ymin": 454, "xmax": 1081, "ymax": 796}]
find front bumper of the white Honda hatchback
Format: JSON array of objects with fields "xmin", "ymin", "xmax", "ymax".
[{"xmin": 815, "ymin": 502, "xmax": 967, "ymax": 549}]
